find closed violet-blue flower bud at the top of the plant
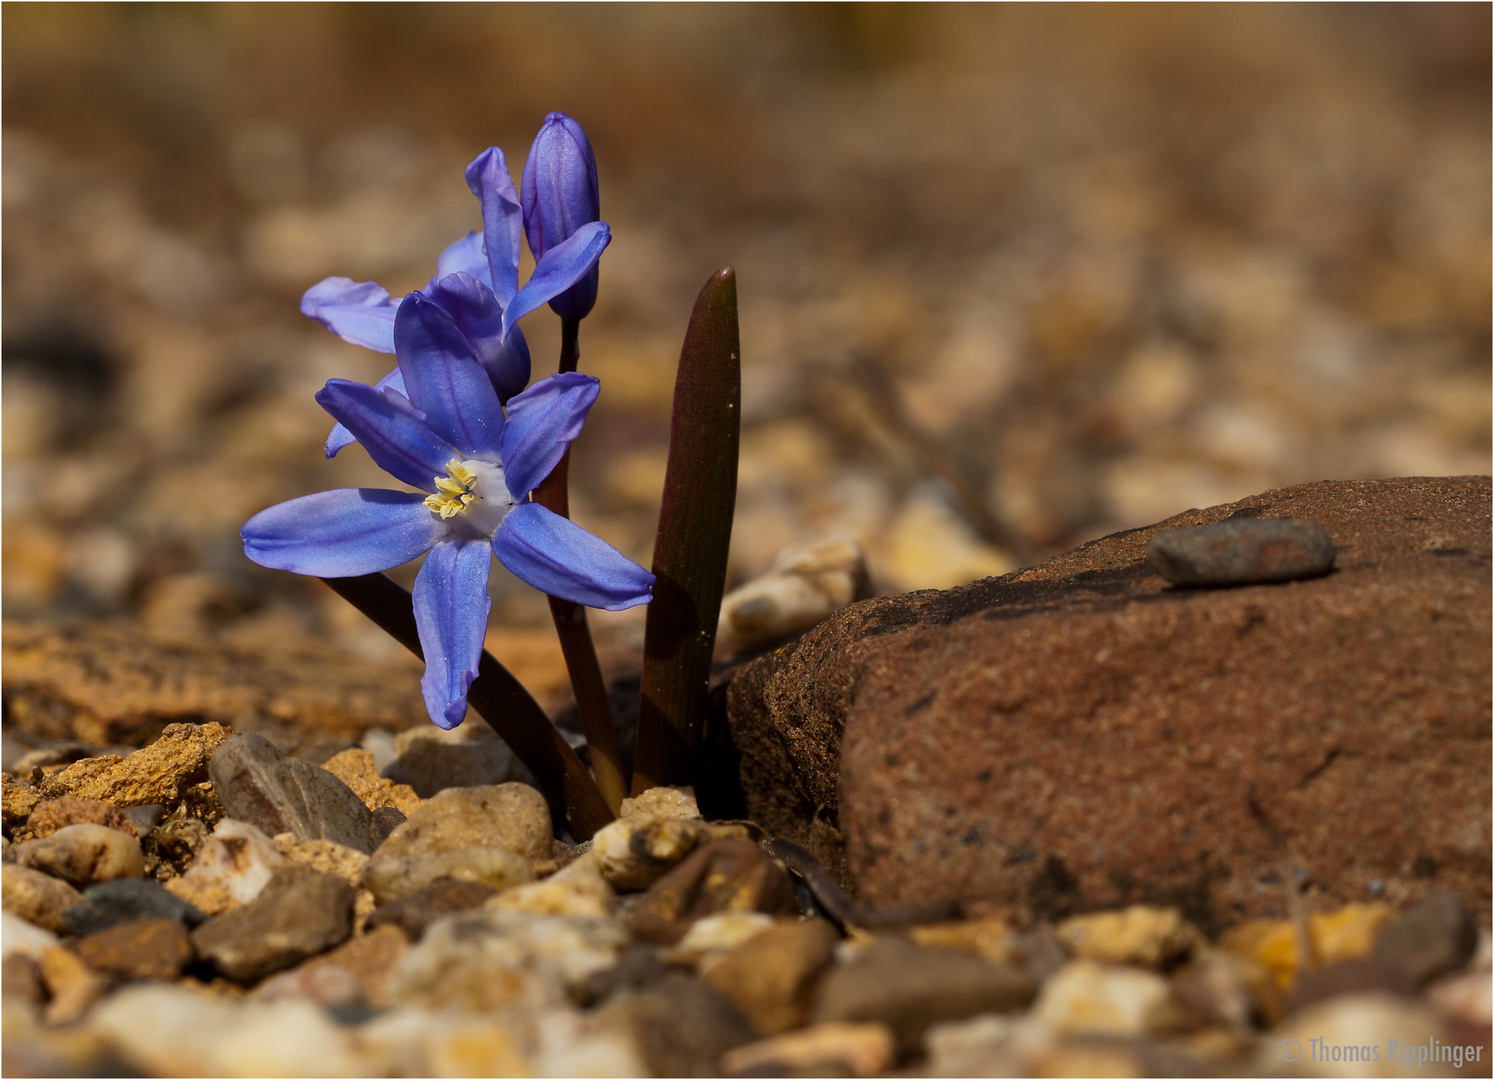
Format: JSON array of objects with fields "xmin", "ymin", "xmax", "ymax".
[{"xmin": 520, "ymin": 112, "xmax": 602, "ymax": 318}]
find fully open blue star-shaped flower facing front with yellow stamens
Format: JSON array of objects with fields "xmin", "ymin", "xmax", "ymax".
[{"xmin": 241, "ymin": 293, "xmax": 654, "ymax": 727}]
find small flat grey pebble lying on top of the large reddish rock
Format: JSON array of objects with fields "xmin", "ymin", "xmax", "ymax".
[{"xmin": 1146, "ymin": 517, "xmax": 1333, "ymax": 586}]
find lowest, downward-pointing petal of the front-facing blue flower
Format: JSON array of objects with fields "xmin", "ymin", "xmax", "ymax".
[{"xmin": 415, "ymin": 539, "xmax": 493, "ymax": 729}]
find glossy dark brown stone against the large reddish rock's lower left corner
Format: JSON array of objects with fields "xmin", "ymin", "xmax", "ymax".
[{"xmin": 627, "ymin": 840, "xmax": 798, "ymax": 946}]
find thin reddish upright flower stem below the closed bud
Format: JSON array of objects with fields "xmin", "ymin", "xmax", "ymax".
[{"xmin": 530, "ymin": 318, "xmax": 627, "ymax": 814}]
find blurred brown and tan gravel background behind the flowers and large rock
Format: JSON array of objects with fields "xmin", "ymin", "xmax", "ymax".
[{"xmin": 3, "ymin": 3, "xmax": 1491, "ymax": 686}]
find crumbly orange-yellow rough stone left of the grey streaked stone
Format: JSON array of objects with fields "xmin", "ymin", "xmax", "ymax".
[{"xmin": 40, "ymin": 723, "xmax": 230, "ymax": 807}]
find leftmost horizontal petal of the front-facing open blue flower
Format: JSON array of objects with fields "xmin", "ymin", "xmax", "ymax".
[{"xmin": 239, "ymin": 487, "xmax": 448, "ymax": 578}]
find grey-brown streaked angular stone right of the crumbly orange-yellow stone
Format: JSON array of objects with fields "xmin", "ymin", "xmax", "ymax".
[{"xmin": 208, "ymin": 732, "xmax": 382, "ymax": 854}]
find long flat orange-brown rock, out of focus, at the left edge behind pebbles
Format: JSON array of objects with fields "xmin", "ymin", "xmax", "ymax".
[{"xmin": 0, "ymin": 621, "xmax": 429, "ymax": 752}]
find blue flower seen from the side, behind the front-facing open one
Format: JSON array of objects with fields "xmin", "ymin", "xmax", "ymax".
[{"xmin": 300, "ymin": 146, "xmax": 613, "ymax": 457}]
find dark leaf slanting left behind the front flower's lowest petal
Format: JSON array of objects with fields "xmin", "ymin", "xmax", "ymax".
[{"xmin": 323, "ymin": 574, "xmax": 614, "ymax": 840}]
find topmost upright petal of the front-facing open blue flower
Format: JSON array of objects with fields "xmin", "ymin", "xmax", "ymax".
[{"xmin": 394, "ymin": 293, "xmax": 503, "ymax": 457}]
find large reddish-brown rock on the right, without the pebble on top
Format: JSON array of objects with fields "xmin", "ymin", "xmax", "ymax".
[{"xmin": 728, "ymin": 477, "xmax": 1491, "ymax": 932}]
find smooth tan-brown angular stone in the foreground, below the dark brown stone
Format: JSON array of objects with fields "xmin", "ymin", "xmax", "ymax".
[{"xmin": 701, "ymin": 919, "xmax": 840, "ymax": 1035}]
